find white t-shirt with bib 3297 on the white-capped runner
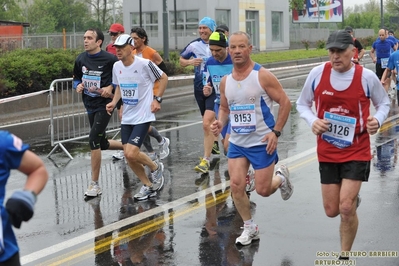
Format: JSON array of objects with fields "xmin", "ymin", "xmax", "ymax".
[{"xmin": 112, "ymin": 56, "xmax": 163, "ymax": 125}]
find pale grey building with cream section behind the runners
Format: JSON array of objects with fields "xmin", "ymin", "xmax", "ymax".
[{"xmin": 123, "ymin": 0, "xmax": 290, "ymax": 51}]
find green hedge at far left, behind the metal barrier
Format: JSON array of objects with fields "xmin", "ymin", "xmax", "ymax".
[{"xmin": 0, "ymin": 49, "xmax": 81, "ymax": 98}]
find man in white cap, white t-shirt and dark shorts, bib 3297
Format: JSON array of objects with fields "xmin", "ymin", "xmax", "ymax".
[{"xmin": 106, "ymin": 34, "xmax": 168, "ymax": 200}]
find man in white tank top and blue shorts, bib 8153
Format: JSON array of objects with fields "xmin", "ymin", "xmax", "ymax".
[{"xmin": 211, "ymin": 31, "xmax": 293, "ymax": 245}]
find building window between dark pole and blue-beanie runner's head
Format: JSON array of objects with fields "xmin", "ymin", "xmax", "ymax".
[{"xmin": 169, "ymin": 10, "xmax": 199, "ymax": 36}]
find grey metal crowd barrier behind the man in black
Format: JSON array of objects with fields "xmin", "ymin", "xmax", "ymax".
[{"xmin": 47, "ymin": 78, "xmax": 120, "ymax": 159}]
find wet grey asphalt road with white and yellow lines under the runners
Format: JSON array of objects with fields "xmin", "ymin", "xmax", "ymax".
[{"xmin": 3, "ymin": 67, "xmax": 399, "ymax": 266}]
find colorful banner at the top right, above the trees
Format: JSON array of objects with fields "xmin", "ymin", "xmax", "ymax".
[{"xmin": 292, "ymin": 0, "xmax": 344, "ymax": 23}]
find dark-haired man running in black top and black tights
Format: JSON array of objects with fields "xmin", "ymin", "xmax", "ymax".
[{"xmin": 73, "ymin": 29, "xmax": 122, "ymax": 197}]
